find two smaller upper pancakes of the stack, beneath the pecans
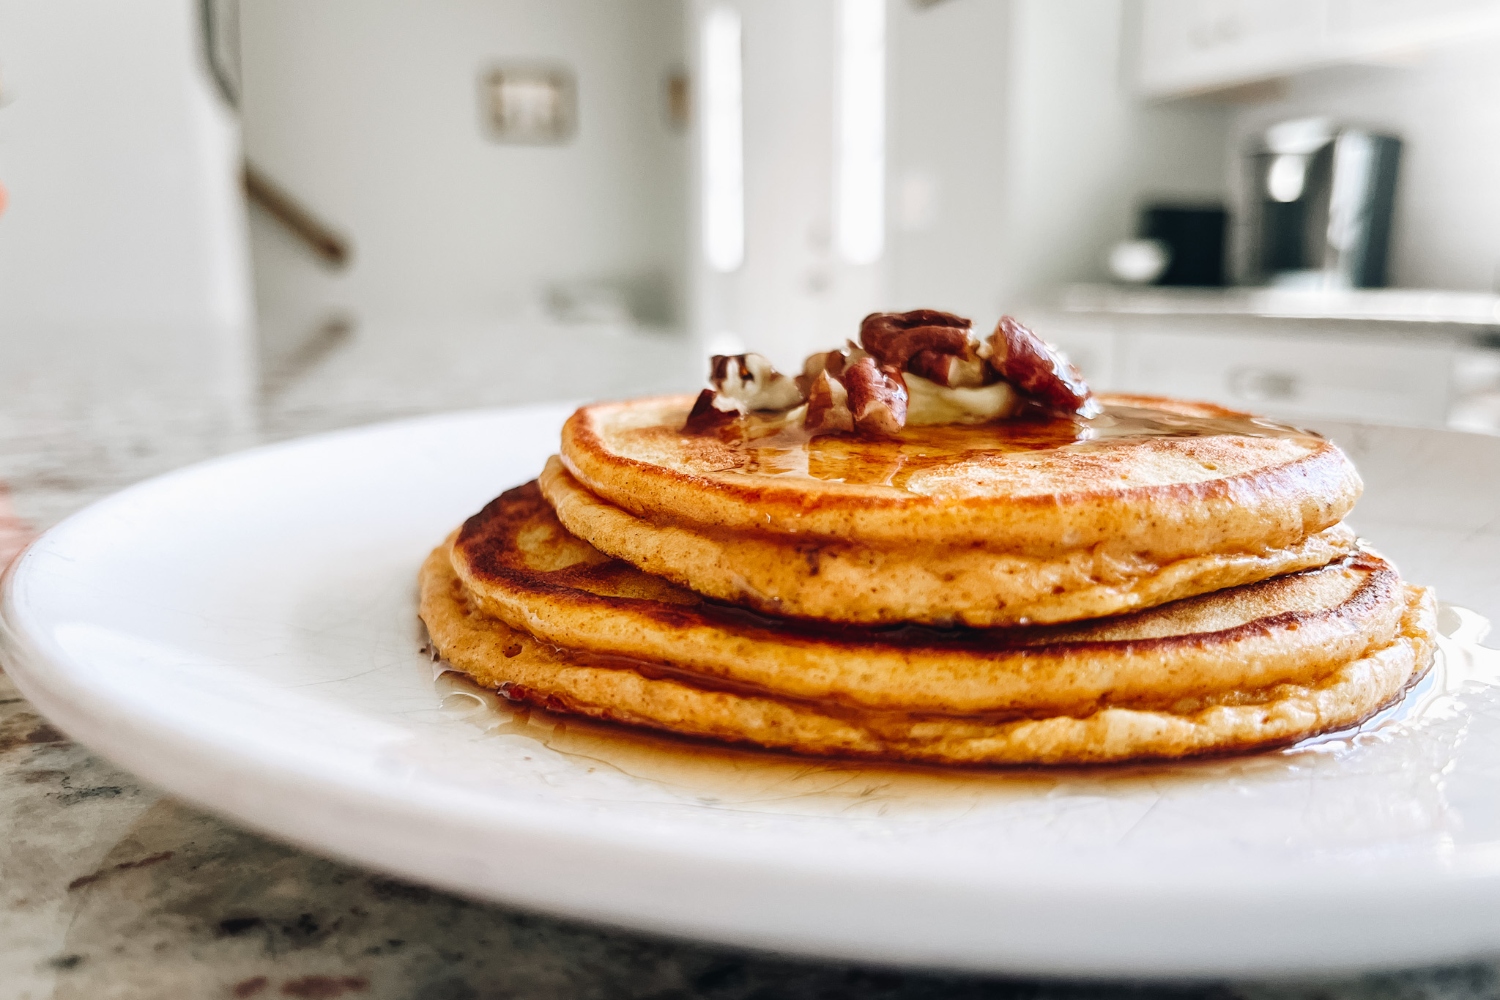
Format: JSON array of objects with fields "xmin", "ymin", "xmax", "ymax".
[{"xmin": 542, "ymin": 396, "xmax": 1362, "ymax": 627}]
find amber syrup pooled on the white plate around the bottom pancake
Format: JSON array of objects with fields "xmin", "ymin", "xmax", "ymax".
[{"xmin": 435, "ymin": 604, "xmax": 1500, "ymax": 820}]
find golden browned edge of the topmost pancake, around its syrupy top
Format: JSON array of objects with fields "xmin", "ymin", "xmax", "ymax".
[{"xmin": 561, "ymin": 396, "xmax": 1364, "ymax": 558}]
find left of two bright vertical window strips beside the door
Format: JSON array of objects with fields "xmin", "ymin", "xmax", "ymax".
[{"xmin": 702, "ymin": 6, "xmax": 746, "ymax": 271}]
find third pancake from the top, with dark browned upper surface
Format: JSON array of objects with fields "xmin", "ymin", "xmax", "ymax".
[{"xmin": 452, "ymin": 483, "xmax": 1400, "ymax": 714}]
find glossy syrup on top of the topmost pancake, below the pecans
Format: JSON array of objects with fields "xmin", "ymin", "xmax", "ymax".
[{"xmin": 699, "ymin": 403, "xmax": 1319, "ymax": 489}]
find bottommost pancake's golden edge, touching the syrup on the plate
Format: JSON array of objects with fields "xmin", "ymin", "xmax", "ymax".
[{"xmin": 419, "ymin": 543, "xmax": 1436, "ymax": 765}]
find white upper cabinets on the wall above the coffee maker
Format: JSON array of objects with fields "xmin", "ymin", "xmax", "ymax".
[{"xmin": 1137, "ymin": 0, "xmax": 1500, "ymax": 97}]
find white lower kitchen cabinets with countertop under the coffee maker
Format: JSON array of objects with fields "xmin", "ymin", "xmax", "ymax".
[{"xmin": 1044, "ymin": 285, "xmax": 1500, "ymax": 427}]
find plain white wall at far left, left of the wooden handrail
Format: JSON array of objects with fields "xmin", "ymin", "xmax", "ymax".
[{"xmin": 0, "ymin": 0, "xmax": 249, "ymax": 335}]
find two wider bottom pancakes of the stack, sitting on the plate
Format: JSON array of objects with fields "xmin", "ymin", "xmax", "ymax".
[{"xmin": 420, "ymin": 484, "xmax": 1434, "ymax": 763}]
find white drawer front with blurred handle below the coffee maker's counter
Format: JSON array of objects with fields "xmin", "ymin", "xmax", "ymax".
[{"xmin": 1119, "ymin": 331, "xmax": 1452, "ymax": 427}]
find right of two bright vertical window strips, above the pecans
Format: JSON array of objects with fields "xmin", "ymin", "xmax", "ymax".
[{"xmin": 834, "ymin": 0, "xmax": 885, "ymax": 264}]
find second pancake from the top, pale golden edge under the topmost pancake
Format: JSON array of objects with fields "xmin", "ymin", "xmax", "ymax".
[{"xmin": 539, "ymin": 456, "xmax": 1358, "ymax": 627}]
